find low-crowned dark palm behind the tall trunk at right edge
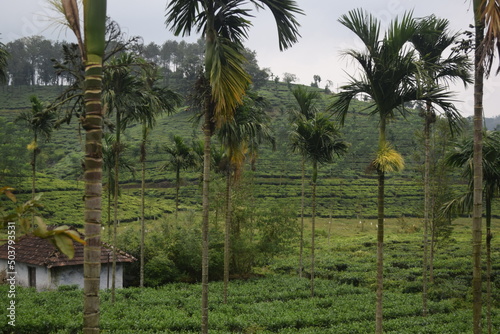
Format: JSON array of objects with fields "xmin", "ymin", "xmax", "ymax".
[{"xmin": 446, "ymin": 131, "xmax": 500, "ymax": 333}]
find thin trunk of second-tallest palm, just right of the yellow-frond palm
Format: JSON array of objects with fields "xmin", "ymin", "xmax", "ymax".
[{"xmin": 422, "ymin": 108, "xmax": 431, "ymax": 317}]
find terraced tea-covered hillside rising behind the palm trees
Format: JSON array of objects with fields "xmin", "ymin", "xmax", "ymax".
[{"xmin": 0, "ymin": 82, "xmax": 492, "ymax": 225}]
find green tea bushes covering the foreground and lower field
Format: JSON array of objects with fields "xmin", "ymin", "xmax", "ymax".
[{"xmin": 0, "ymin": 219, "xmax": 500, "ymax": 334}]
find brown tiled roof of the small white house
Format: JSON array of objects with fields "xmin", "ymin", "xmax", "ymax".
[{"xmin": 0, "ymin": 234, "xmax": 137, "ymax": 268}]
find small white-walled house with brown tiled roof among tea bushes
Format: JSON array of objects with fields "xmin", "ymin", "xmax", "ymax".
[{"xmin": 0, "ymin": 234, "xmax": 137, "ymax": 291}]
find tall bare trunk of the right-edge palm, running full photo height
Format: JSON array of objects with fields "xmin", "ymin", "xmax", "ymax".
[{"xmin": 472, "ymin": 0, "xmax": 484, "ymax": 334}]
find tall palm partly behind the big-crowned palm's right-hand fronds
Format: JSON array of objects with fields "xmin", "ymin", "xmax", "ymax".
[{"xmin": 410, "ymin": 15, "xmax": 472, "ymax": 316}]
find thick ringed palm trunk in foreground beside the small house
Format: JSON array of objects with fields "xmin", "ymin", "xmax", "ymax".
[{"xmin": 83, "ymin": 0, "xmax": 106, "ymax": 334}]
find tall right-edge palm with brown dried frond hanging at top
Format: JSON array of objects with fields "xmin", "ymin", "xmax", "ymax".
[{"xmin": 472, "ymin": 0, "xmax": 500, "ymax": 334}]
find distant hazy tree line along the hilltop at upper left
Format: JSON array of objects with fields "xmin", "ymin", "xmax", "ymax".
[{"xmin": 5, "ymin": 36, "xmax": 270, "ymax": 88}]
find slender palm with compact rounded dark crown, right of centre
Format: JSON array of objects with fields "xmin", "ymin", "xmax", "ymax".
[{"xmin": 290, "ymin": 113, "xmax": 347, "ymax": 297}]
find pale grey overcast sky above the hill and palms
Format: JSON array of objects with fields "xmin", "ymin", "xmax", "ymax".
[{"xmin": 0, "ymin": 0, "xmax": 500, "ymax": 117}]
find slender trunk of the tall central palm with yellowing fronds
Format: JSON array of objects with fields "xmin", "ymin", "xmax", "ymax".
[{"xmin": 201, "ymin": 110, "xmax": 212, "ymax": 334}]
